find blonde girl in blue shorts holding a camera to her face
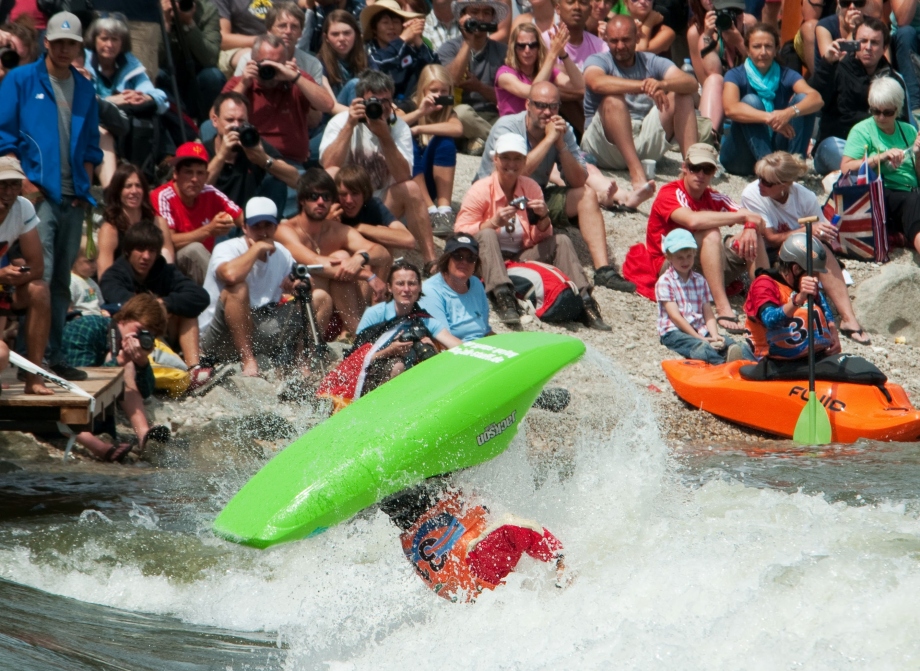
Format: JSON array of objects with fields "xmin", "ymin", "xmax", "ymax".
[{"xmin": 397, "ymin": 65, "xmax": 463, "ymax": 237}]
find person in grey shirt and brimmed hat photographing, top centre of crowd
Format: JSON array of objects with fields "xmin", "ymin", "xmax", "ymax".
[{"xmin": 438, "ymin": 0, "xmax": 508, "ymax": 156}]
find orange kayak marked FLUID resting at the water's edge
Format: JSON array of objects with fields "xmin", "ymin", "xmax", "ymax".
[{"xmin": 661, "ymin": 359, "xmax": 920, "ymax": 443}]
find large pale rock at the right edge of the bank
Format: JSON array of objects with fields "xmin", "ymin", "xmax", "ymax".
[{"xmin": 853, "ymin": 264, "xmax": 920, "ymax": 345}]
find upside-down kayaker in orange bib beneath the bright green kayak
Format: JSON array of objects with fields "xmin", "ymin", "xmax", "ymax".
[{"xmin": 380, "ymin": 478, "xmax": 571, "ymax": 602}]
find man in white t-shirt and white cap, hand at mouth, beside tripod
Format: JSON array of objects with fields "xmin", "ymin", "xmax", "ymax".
[{"xmin": 198, "ymin": 197, "xmax": 301, "ymax": 376}]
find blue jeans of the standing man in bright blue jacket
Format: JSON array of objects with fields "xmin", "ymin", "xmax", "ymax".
[{"xmin": 37, "ymin": 196, "xmax": 85, "ymax": 366}]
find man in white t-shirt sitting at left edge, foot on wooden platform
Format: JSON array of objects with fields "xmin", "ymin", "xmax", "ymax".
[{"xmin": 0, "ymin": 156, "xmax": 54, "ymax": 396}]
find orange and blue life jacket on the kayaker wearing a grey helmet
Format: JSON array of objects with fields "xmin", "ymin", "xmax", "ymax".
[{"xmin": 746, "ymin": 278, "xmax": 831, "ymax": 359}]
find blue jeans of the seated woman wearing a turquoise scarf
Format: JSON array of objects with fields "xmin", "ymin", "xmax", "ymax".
[{"xmin": 719, "ymin": 93, "xmax": 815, "ymax": 175}]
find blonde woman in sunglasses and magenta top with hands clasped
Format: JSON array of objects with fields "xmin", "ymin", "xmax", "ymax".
[{"xmin": 495, "ymin": 23, "xmax": 584, "ymax": 116}]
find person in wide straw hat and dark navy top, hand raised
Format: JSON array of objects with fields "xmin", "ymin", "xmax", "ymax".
[{"xmin": 361, "ymin": 0, "xmax": 438, "ymax": 101}]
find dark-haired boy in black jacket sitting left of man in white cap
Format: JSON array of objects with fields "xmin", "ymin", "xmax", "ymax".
[{"xmin": 99, "ymin": 220, "xmax": 208, "ymax": 368}]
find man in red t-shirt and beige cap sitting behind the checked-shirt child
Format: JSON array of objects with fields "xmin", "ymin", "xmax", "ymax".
[{"xmin": 625, "ymin": 143, "xmax": 769, "ymax": 334}]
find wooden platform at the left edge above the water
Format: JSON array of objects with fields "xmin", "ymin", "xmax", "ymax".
[{"xmin": 0, "ymin": 366, "xmax": 125, "ymax": 431}]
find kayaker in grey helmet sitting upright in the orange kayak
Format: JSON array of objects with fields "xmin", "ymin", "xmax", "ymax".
[{"xmin": 741, "ymin": 233, "xmax": 887, "ymax": 385}]
